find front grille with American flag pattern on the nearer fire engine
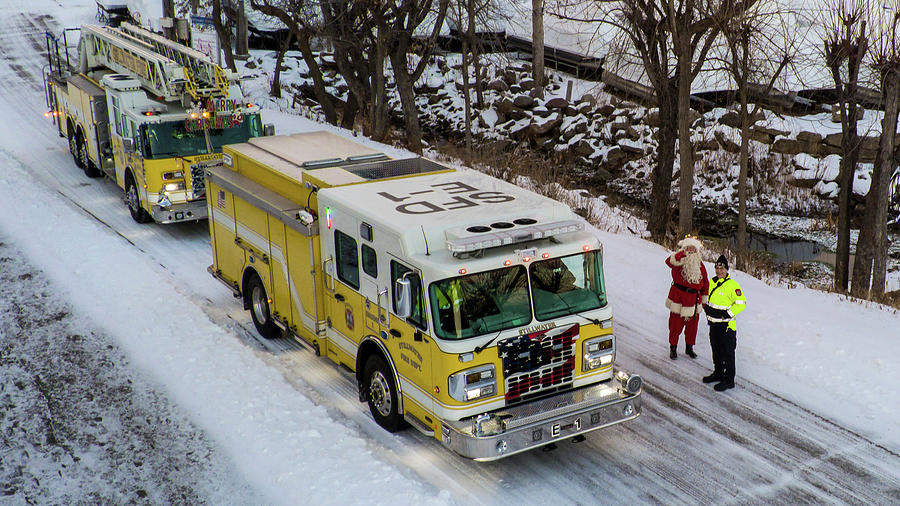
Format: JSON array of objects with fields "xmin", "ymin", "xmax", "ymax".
[{"xmin": 497, "ymin": 323, "xmax": 579, "ymax": 402}]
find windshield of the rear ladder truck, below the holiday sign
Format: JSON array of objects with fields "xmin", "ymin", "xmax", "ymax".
[{"xmin": 140, "ymin": 114, "xmax": 263, "ymax": 159}]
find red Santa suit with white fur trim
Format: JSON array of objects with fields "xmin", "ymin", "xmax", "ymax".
[{"xmin": 666, "ymin": 248, "xmax": 709, "ymax": 346}]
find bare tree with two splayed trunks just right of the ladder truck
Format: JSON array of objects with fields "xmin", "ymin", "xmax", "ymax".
[{"xmin": 251, "ymin": 0, "xmax": 337, "ymax": 125}]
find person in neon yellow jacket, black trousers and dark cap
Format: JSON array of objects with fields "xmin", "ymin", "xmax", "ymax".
[{"xmin": 703, "ymin": 255, "xmax": 747, "ymax": 392}]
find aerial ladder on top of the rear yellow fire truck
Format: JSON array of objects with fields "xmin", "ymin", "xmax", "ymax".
[{"xmin": 79, "ymin": 23, "xmax": 238, "ymax": 105}]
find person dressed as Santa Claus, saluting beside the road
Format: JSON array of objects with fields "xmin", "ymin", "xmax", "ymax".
[{"xmin": 666, "ymin": 237, "xmax": 709, "ymax": 359}]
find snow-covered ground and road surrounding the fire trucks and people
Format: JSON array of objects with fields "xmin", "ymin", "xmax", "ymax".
[{"xmin": 0, "ymin": 0, "xmax": 900, "ymax": 504}]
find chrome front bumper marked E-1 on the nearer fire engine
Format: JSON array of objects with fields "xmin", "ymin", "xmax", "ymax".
[{"xmin": 441, "ymin": 379, "xmax": 641, "ymax": 461}]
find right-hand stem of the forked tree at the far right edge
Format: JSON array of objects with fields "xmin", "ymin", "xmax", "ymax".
[{"xmin": 866, "ymin": 68, "xmax": 900, "ymax": 299}]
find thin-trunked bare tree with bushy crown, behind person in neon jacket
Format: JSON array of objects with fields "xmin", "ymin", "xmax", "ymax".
[{"xmin": 716, "ymin": 0, "xmax": 799, "ymax": 269}]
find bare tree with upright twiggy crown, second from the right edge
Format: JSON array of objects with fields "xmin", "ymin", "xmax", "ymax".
[{"xmin": 823, "ymin": 0, "xmax": 870, "ymax": 292}]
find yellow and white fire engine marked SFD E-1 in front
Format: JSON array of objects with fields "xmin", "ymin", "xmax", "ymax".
[{"xmin": 206, "ymin": 132, "xmax": 641, "ymax": 460}]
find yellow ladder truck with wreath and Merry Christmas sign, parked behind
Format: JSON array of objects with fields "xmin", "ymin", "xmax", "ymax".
[{"xmin": 46, "ymin": 23, "xmax": 271, "ymax": 223}]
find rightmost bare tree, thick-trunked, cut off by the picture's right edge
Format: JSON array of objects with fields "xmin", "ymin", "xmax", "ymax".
[{"xmin": 851, "ymin": 0, "xmax": 900, "ymax": 298}]
